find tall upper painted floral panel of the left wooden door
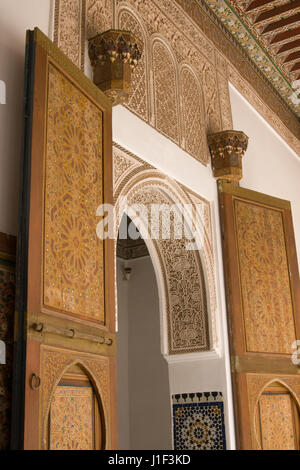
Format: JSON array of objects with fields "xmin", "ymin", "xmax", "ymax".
[{"xmin": 44, "ymin": 65, "xmax": 105, "ymax": 323}]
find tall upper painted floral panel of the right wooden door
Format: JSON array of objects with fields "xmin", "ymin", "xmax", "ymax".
[{"xmin": 235, "ymin": 200, "xmax": 296, "ymax": 354}]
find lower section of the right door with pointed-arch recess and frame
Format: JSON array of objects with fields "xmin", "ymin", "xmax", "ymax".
[{"xmin": 237, "ymin": 373, "xmax": 300, "ymax": 450}]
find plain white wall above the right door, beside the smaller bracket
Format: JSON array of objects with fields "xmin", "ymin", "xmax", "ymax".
[{"xmin": 230, "ymin": 85, "xmax": 300, "ymax": 266}]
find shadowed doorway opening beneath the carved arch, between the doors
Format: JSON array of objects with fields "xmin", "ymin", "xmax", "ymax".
[{"xmin": 116, "ymin": 214, "xmax": 172, "ymax": 450}]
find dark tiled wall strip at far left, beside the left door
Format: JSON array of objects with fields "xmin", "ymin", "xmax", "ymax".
[{"xmin": 0, "ymin": 233, "xmax": 15, "ymax": 450}]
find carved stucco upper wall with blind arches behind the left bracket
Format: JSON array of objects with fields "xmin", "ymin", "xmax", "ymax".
[{"xmin": 55, "ymin": 0, "xmax": 232, "ymax": 165}]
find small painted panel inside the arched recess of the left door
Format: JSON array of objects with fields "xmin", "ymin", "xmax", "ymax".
[{"xmin": 49, "ymin": 386, "xmax": 94, "ymax": 450}]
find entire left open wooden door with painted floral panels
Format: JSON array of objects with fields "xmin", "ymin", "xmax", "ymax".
[{"xmin": 12, "ymin": 29, "xmax": 116, "ymax": 449}]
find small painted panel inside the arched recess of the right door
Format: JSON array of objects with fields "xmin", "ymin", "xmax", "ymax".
[{"xmin": 259, "ymin": 393, "xmax": 296, "ymax": 450}]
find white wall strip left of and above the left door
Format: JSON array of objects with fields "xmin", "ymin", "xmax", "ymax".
[{"xmin": 0, "ymin": 0, "xmax": 52, "ymax": 235}]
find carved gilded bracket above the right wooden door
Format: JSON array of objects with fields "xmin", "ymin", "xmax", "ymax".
[{"xmin": 208, "ymin": 130, "xmax": 249, "ymax": 184}]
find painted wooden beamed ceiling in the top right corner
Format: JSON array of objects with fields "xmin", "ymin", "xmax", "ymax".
[{"xmin": 205, "ymin": 0, "xmax": 300, "ymax": 117}]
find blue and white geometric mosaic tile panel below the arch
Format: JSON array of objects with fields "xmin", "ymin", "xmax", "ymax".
[{"xmin": 172, "ymin": 392, "xmax": 226, "ymax": 450}]
